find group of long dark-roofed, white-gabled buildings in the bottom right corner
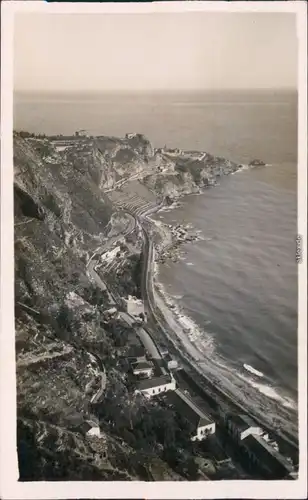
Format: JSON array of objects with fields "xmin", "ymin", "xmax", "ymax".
[{"xmin": 225, "ymin": 414, "xmax": 297, "ymax": 479}]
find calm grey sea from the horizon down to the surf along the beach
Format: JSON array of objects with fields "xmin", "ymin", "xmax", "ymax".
[{"xmin": 14, "ymin": 90, "xmax": 298, "ymax": 433}]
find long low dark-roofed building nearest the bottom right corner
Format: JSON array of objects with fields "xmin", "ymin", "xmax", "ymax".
[{"xmin": 242, "ymin": 434, "xmax": 294, "ymax": 479}]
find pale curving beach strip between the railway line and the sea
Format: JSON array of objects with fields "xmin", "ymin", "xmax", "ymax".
[{"xmin": 147, "ymin": 185, "xmax": 297, "ymax": 442}]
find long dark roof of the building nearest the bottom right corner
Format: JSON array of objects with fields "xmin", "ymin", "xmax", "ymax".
[{"xmin": 243, "ymin": 434, "xmax": 293, "ymax": 478}]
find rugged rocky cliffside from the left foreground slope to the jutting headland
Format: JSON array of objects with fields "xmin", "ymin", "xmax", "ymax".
[{"xmin": 14, "ymin": 133, "xmax": 241, "ymax": 480}]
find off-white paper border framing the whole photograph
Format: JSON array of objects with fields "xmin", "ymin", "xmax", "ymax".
[{"xmin": 0, "ymin": 0, "xmax": 307, "ymax": 500}]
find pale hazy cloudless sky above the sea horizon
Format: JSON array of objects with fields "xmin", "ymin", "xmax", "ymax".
[{"xmin": 14, "ymin": 12, "xmax": 297, "ymax": 91}]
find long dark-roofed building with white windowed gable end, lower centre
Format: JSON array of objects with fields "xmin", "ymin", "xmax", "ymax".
[{"xmin": 169, "ymin": 389, "xmax": 216, "ymax": 441}]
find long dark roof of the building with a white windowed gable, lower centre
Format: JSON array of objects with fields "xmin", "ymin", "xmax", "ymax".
[{"xmin": 170, "ymin": 389, "xmax": 214, "ymax": 428}]
